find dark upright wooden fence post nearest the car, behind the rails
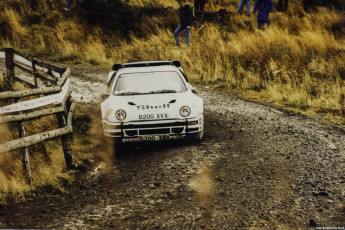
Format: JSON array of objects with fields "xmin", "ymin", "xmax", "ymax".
[{"xmin": 56, "ymin": 101, "xmax": 74, "ymax": 169}]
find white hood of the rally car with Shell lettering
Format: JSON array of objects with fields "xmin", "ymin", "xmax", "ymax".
[{"xmin": 101, "ymin": 91, "xmax": 203, "ymax": 122}]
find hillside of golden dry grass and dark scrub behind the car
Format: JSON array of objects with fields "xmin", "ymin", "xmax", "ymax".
[{"xmin": 0, "ymin": 0, "xmax": 345, "ymax": 121}]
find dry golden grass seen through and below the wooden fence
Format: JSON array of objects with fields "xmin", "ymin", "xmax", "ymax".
[{"xmin": 0, "ymin": 104, "xmax": 73, "ymax": 204}]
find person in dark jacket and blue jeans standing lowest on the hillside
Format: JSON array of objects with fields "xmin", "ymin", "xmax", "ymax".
[{"xmin": 174, "ymin": 0, "xmax": 193, "ymax": 47}]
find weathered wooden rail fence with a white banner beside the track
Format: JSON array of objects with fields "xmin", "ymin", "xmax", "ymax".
[{"xmin": 0, "ymin": 48, "xmax": 75, "ymax": 179}]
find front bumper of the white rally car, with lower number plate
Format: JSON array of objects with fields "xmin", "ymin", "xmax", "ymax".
[{"xmin": 103, "ymin": 115, "xmax": 204, "ymax": 143}]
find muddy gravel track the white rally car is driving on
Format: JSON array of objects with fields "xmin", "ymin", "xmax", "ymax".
[{"xmin": 0, "ymin": 61, "xmax": 345, "ymax": 229}]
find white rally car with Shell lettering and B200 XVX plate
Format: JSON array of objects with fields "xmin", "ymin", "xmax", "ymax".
[{"xmin": 101, "ymin": 61, "xmax": 204, "ymax": 143}]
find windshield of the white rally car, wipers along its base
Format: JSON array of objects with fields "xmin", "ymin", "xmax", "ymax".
[{"xmin": 114, "ymin": 71, "xmax": 187, "ymax": 95}]
